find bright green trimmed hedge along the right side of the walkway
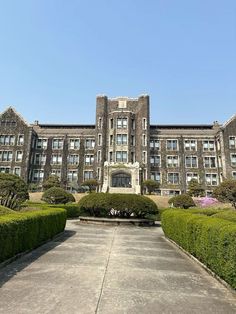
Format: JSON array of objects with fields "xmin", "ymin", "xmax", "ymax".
[{"xmin": 162, "ymin": 210, "xmax": 236, "ymax": 289}]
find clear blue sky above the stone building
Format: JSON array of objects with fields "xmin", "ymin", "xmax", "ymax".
[{"xmin": 0, "ymin": 0, "xmax": 236, "ymax": 124}]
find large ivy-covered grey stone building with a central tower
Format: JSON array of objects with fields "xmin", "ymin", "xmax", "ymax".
[{"xmin": 0, "ymin": 95, "xmax": 236, "ymax": 195}]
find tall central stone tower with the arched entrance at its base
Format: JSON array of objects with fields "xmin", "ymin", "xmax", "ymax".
[{"xmin": 94, "ymin": 95, "xmax": 150, "ymax": 194}]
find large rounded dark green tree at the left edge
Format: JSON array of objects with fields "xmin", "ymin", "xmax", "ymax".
[{"xmin": 0, "ymin": 173, "xmax": 29, "ymax": 209}]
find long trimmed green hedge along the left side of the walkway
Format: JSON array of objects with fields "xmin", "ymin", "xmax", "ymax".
[{"xmin": 0, "ymin": 209, "xmax": 66, "ymax": 262}]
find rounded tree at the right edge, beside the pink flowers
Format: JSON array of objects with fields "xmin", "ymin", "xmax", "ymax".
[{"xmin": 213, "ymin": 180, "xmax": 236, "ymax": 209}]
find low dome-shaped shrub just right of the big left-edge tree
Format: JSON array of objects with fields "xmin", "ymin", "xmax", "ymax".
[{"xmin": 42, "ymin": 187, "xmax": 75, "ymax": 204}]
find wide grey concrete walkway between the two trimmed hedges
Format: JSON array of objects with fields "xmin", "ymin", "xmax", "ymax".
[{"xmin": 0, "ymin": 221, "xmax": 236, "ymax": 314}]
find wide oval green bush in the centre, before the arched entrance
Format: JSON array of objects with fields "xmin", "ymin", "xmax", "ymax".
[{"xmin": 79, "ymin": 193, "xmax": 158, "ymax": 218}]
